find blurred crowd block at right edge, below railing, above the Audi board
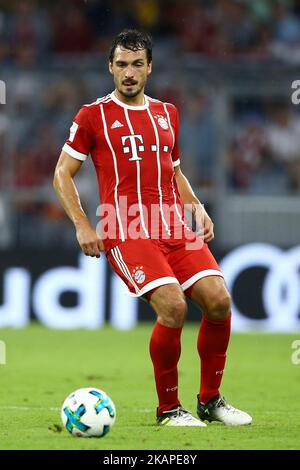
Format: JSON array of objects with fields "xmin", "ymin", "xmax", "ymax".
[{"xmin": 228, "ymin": 98, "xmax": 300, "ymax": 195}]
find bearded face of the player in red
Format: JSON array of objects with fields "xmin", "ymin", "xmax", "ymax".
[{"xmin": 109, "ymin": 46, "xmax": 152, "ymax": 98}]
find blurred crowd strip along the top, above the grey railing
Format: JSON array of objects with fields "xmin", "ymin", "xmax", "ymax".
[{"xmin": 0, "ymin": 0, "xmax": 300, "ymax": 67}]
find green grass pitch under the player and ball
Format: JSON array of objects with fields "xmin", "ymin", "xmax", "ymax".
[{"xmin": 0, "ymin": 324, "xmax": 300, "ymax": 450}]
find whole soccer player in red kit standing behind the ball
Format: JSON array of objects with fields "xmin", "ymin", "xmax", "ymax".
[{"xmin": 54, "ymin": 30, "xmax": 252, "ymax": 427}]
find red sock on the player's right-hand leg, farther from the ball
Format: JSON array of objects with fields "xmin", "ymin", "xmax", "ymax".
[{"xmin": 197, "ymin": 313, "xmax": 231, "ymax": 403}]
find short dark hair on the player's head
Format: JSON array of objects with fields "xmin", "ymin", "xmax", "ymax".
[{"xmin": 109, "ymin": 29, "xmax": 152, "ymax": 64}]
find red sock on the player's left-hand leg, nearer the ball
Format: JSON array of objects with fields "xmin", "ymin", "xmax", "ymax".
[{"xmin": 150, "ymin": 322, "xmax": 182, "ymax": 416}]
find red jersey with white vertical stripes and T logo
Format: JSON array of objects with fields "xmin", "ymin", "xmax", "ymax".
[{"xmin": 63, "ymin": 92, "xmax": 186, "ymax": 251}]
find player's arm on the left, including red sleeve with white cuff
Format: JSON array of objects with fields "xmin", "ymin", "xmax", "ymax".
[{"xmin": 53, "ymin": 108, "xmax": 103, "ymax": 258}]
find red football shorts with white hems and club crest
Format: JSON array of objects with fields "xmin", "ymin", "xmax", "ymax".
[{"xmin": 106, "ymin": 239, "xmax": 223, "ymax": 297}]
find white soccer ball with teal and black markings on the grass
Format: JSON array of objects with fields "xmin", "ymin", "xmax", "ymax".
[{"xmin": 61, "ymin": 388, "xmax": 116, "ymax": 437}]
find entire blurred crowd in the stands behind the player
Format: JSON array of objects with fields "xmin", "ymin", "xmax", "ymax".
[{"xmin": 0, "ymin": 0, "xmax": 300, "ymax": 248}]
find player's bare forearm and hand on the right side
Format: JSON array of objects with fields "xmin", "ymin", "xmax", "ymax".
[{"xmin": 174, "ymin": 165, "xmax": 215, "ymax": 243}]
